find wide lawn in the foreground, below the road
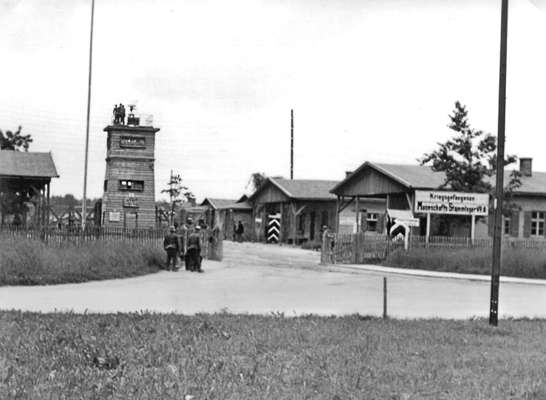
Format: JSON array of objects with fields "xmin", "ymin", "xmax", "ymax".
[{"xmin": 0, "ymin": 312, "xmax": 546, "ymax": 400}]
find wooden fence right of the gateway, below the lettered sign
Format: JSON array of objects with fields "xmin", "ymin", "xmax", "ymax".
[{"xmin": 321, "ymin": 233, "xmax": 546, "ymax": 264}]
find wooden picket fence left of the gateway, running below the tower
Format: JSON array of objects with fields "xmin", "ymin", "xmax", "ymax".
[{"xmin": 0, "ymin": 225, "xmax": 223, "ymax": 261}]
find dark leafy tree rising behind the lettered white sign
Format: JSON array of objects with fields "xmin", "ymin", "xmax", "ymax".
[{"xmin": 418, "ymin": 101, "xmax": 521, "ymax": 234}]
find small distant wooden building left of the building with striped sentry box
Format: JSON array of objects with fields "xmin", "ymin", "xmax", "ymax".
[{"xmin": 201, "ymin": 196, "xmax": 252, "ymax": 240}]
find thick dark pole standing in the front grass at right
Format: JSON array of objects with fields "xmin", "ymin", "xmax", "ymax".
[{"xmin": 489, "ymin": 0, "xmax": 508, "ymax": 326}]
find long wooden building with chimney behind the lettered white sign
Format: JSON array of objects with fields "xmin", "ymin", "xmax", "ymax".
[{"xmin": 332, "ymin": 158, "xmax": 546, "ymax": 238}]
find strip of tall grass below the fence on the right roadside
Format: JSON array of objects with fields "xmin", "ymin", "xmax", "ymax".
[{"xmin": 383, "ymin": 248, "xmax": 546, "ymax": 279}]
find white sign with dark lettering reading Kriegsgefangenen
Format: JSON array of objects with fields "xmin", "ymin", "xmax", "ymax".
[{"xmin": 415, "ymin": 190, "xmax": 489, "ymax": 215}]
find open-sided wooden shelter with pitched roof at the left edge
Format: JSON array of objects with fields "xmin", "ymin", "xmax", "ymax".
[{"xmin": 0, "ymin": 150, "xmax": 59, "ymax": 227}]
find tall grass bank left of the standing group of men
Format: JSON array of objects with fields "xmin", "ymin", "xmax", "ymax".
[{"xmin": 0, "ymin": 238, "xmax": 165, "ymax": 285}]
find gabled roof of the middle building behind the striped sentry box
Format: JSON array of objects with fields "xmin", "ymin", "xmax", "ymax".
[{"xmin": 249, "ymin": 178, "xmax": 338, "ymax": 200}]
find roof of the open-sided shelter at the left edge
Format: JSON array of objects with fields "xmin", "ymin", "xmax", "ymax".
[{"xmin": 0, "ymin": 150, "xmax": 59, "ymax": 178}]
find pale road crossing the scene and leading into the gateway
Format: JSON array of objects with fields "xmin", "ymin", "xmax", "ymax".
[{"xmin": 0, "ymin": 242, "xmax": 546, "ymax": 318}]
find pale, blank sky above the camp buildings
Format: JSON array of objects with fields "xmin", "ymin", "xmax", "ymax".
[{"xmin": 0, "ymin": 0, "xmax": 546, "ymax": 200}]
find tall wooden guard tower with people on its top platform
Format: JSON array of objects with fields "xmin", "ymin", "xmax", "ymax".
[{"xmin": 102, "ymin": 104, "xmax": 159, "ymax": 229}]
